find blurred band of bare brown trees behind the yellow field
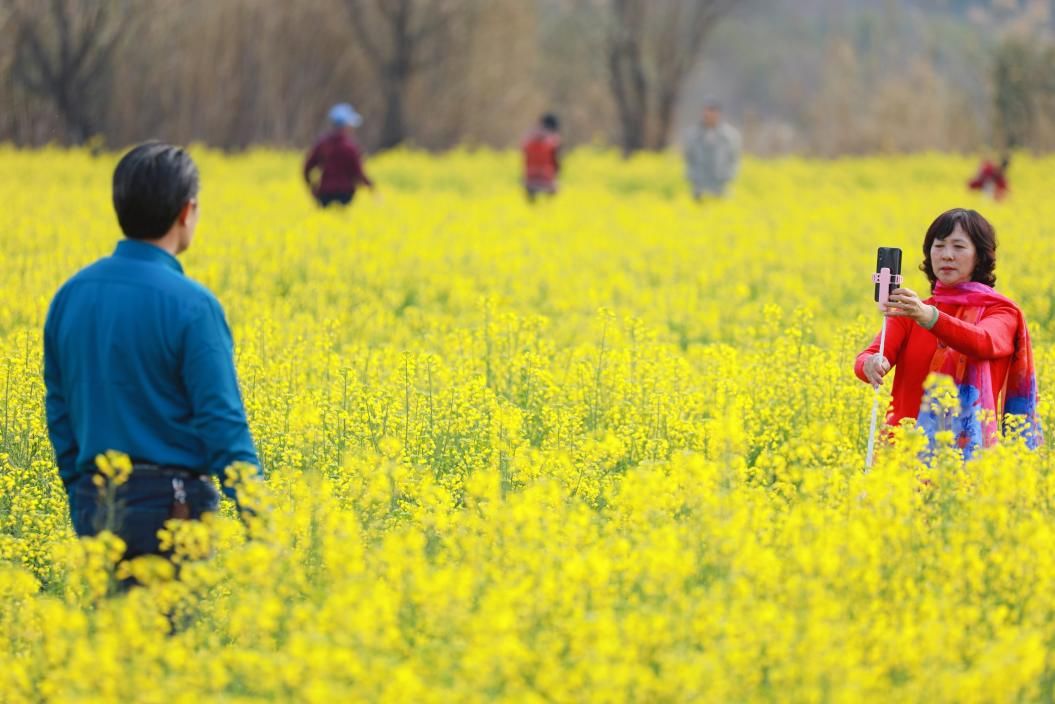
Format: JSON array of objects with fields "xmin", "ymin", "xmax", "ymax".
[{"xmin": 0, "ymin": 0, "xmax": 1055, "ymax": 154}]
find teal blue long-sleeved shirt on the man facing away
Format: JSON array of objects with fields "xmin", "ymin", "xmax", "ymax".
[{"xmin": 44, "ymin": 240, "xmax": 260, "ymax": 484}]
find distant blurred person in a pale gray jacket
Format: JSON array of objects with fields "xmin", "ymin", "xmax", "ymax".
[{"xmin": 685, "ymin": 100, "xmax": 741, "ymax": 201}]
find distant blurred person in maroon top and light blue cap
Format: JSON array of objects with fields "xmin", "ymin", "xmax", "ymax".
[{"xmin": 304, "ymin": 102, "xmax": 373, "ymax": 208}]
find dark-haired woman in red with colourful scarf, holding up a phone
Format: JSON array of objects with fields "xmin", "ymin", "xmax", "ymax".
[{"xmin": 853, "ymin": 208, "xmax": 1042, "ymax": 457}]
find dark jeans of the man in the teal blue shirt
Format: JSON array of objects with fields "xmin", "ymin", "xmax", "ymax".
[{"xmin": 66, "ymin": 472, "xmax": 219, "ymax": 559}]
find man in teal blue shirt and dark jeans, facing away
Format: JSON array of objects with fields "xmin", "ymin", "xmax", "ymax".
[{"xmin": 44, "ymin": 142, "xmax": 260, "ymax": 558}]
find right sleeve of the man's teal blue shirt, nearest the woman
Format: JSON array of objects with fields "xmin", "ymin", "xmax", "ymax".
[{"xmin": 183, "ymin": 301, "xmax": 260, "ymax": 498}]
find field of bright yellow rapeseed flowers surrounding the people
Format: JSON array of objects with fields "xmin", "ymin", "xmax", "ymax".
[{"xmin": 0, "ymin": 147, "xmax": 1055, "ymax": 703}]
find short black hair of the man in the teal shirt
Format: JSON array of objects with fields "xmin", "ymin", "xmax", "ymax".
[{"xmin": 114, "ymin": 141, "xmax": 198, "ymax": 240}]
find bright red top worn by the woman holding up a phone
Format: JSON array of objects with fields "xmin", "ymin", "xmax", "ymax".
[{"xmin": 853, "ymin": 299, "xmax": 1018, "ymax": 425}]
